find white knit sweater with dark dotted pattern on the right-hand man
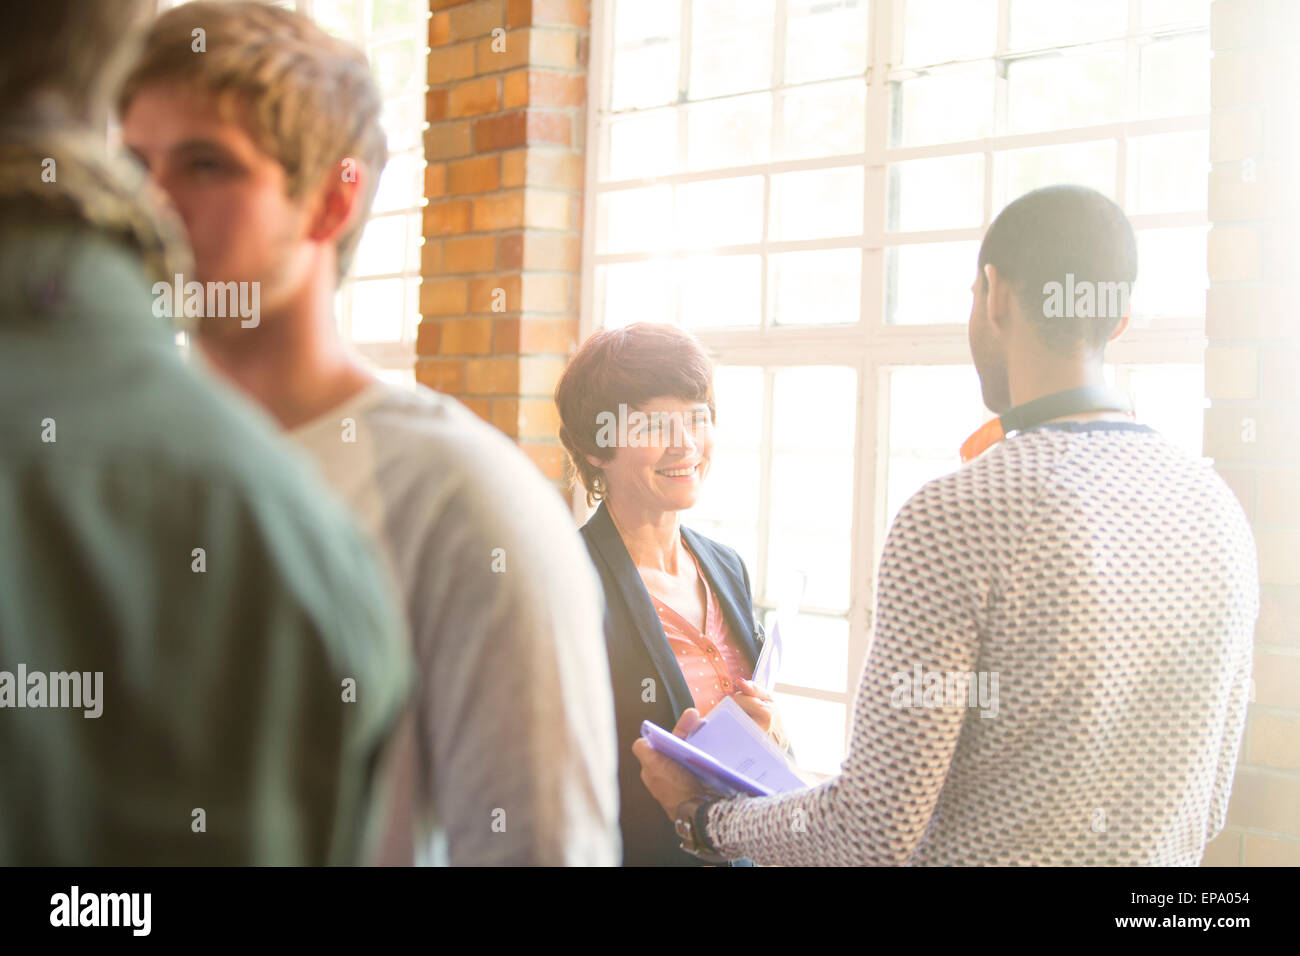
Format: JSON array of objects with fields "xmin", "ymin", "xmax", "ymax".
[{"xmin": 706, "ymin": 421, "xmax": 1260, "ymax": 865}]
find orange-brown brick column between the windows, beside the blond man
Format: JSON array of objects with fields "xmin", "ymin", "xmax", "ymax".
[{"xmin": 416, "ymin": 0, "xmax": 590, "ymax": 481}]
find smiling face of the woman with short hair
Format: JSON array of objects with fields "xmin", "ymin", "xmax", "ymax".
[{"xmin": 589, "ymin": 395, "xmax": 714, "ymax": 512}]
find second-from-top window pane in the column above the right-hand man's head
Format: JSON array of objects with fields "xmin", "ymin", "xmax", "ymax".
[{"xmin": 1006, "ymin": 47, "xmax": 1125, "ymax": 133}]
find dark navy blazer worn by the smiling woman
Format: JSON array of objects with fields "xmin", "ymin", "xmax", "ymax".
[{"xmin": 582, "ymin": 502, "xmax": 763, "ymax": 866}]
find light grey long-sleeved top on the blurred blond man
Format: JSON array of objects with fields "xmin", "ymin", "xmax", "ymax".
[{"xmin": 291, "ymin": 382, "xmax": 620, "ymax": 865}]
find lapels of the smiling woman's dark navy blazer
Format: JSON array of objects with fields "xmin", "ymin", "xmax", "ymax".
[{"xmin": 585, "ymin": 501, "xmax": 758, "ymax": 730}]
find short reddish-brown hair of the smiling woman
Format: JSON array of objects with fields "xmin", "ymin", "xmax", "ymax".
[{"xmin": 555, "ymin": 323, "xmax": 716, "ymax": 505}]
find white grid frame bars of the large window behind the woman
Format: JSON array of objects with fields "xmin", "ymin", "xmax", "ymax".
[{"xmin": 585, "ymin": 0, "xmax": 1209, "ymax": 764}]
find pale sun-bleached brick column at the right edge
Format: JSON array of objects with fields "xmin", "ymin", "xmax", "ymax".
[{"xmin": 1205, "ymin": 0, "xmax": 1300, "ymax": 866}]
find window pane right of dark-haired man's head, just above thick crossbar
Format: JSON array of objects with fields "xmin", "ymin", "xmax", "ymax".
[{"xmin": 1132, "ymin": 226, "xmax": 1210, "ymax": 317}]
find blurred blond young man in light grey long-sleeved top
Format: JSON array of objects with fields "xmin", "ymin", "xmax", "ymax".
[{"xmin": 120, "ymin": 3, "xmax": 619, "ymax": 865}]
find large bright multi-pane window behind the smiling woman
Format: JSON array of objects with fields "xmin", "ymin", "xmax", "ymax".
[{"xmin": 582, "ymin": 0, "xmax": 1210, "ymax": 773}]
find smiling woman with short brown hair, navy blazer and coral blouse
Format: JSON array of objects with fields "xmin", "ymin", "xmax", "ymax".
[{"xmin": 555, "ymin": 323, "xmax": 784, "ymax": 866}]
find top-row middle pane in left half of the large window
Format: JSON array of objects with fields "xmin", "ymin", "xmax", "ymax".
[{"xmin": 686, "ymin": 0, "xmax": 776, "ymax": 100}]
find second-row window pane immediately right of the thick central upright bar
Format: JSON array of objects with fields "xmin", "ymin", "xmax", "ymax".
[{"xmin": 889, "ymin": 64, "xmax": 993, "ymax": 146}]
